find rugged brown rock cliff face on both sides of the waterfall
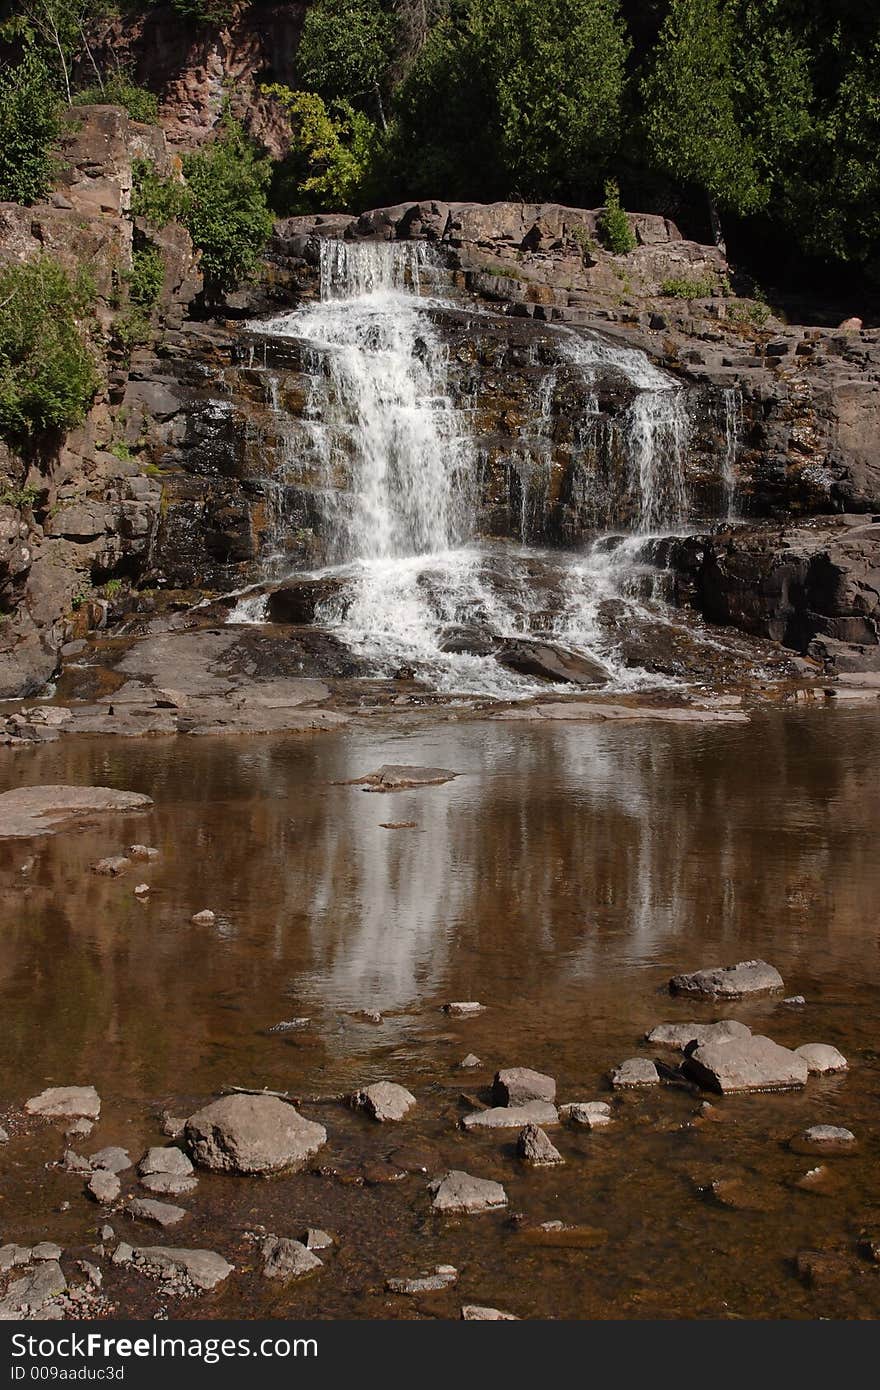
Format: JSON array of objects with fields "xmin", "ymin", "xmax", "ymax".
[{"xmin": 0, "ymin": 109, "xmax": 880, "ymax": 696}]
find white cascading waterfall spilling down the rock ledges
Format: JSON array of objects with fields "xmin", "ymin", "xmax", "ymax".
[{"xmin": 239, "ymin": 240, "xmax": 711, "ymax": 696}]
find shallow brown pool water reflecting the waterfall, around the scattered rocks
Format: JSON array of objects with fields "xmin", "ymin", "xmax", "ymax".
[{"xmin": 0, "ymin": 709, "xmax": 880, "ymax": 1318}]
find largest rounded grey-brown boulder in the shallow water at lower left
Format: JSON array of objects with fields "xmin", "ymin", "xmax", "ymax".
[{"xmin": 185, "ymin": 1095, "xmax": 327, "ymax": 1173}]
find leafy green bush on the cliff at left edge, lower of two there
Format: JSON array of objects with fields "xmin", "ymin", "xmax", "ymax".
[{"xmin": 0, "ymin": 256, "xmax": 99, "ymax": 439}]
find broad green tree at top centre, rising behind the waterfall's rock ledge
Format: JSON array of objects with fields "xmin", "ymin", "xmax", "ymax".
[{"xmin": 396, "ymin": 0, "xmax": 630, "ymax": 196}]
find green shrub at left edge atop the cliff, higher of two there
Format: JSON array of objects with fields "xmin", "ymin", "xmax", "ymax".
[{"xmin": 0, "ymin": 53, "xmax": 61, "ymax": 203}]
